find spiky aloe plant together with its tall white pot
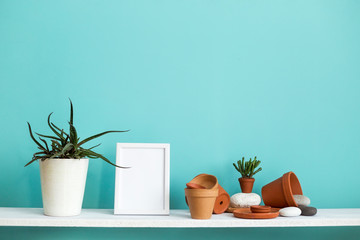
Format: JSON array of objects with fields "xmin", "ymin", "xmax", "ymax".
[{"xmin": 25, "ymin": 100, "xmax": 128, "ymax": 216}]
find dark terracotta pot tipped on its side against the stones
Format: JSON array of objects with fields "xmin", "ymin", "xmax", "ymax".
[{"xmin": 261, "ymin": 172, "xmax": 303, "ymax": 208}]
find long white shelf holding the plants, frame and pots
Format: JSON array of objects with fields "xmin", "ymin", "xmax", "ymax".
[{"xmin": 0, "ymin": 208, "xmax": 360, "ymax": 228}]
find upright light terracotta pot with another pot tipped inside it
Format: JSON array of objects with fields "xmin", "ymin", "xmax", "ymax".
[{"xmin": 185, "ymin": 188, "xmax": 219, "ymax": 219}]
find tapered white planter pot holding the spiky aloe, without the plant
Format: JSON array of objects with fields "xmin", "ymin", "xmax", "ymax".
[{"xmin": 39, "ymin": 159, "xmax": 89, "ymax": 217}]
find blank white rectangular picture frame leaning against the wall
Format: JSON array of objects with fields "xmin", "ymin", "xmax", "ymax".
[{"xmin": 114, "ymin": 143, "xmax": 170, "ymax": 215}]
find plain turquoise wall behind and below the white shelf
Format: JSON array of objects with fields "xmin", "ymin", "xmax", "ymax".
[{"xmin": 0, "ymin": 0, "xmax": 360, "ymax": 239}]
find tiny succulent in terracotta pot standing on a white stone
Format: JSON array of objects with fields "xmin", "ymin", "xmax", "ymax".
[{"xmin": 233, "ymin": 156, "xmax": 262, "ymax": 193}]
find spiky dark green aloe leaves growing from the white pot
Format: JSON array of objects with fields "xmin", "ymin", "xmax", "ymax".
[{"xmin": 25, "ymin": 99, "xmax": 129, "ymax": 168}]
